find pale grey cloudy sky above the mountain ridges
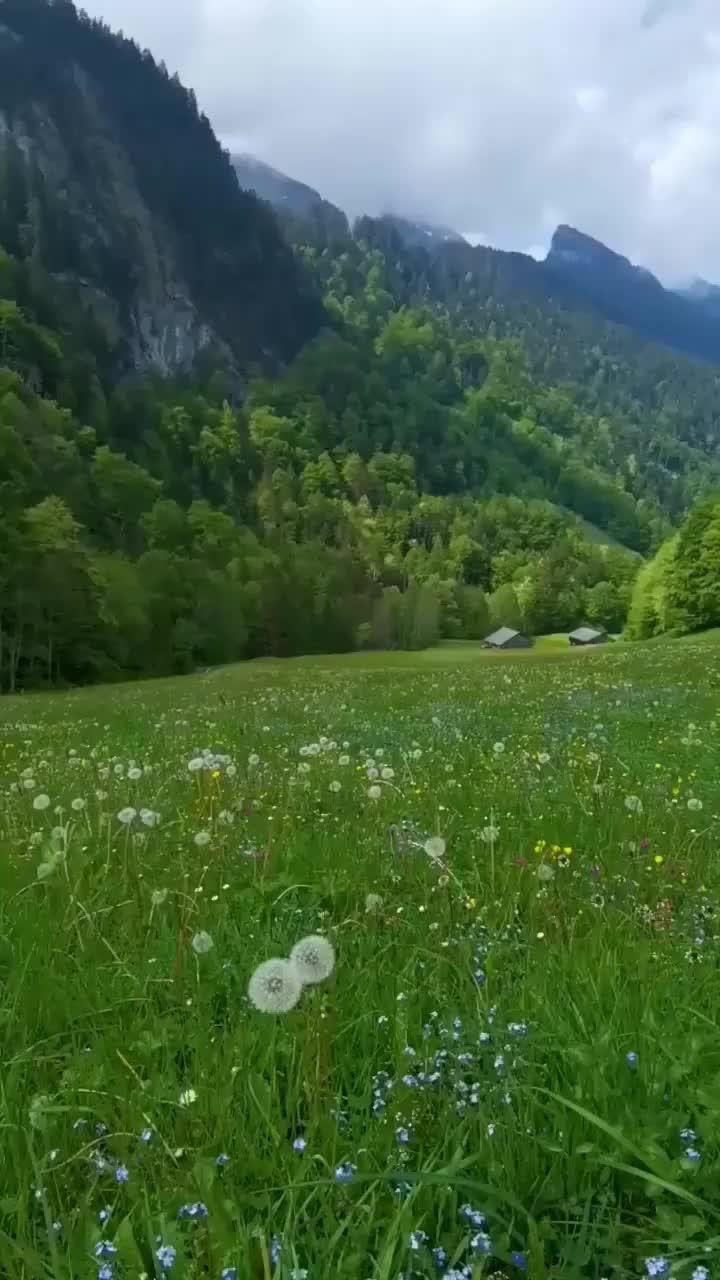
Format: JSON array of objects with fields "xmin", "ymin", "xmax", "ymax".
[{"xmin": 83, "ymin": 0, "xmax": 720, "ymax": 282}]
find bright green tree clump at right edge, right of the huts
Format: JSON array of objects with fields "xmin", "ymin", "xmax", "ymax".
[{"xmin": 628, "ymin": 493, "xmax": 720, "ymax": 640}]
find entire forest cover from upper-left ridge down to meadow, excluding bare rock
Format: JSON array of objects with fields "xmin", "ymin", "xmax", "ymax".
[{"xmin": 0, "ymin": 0, "xmax": 720, "ymax": 692}]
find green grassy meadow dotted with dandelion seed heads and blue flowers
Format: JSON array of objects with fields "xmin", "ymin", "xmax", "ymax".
[{"xmin": 0, "ymin": 636, "xmax": 720, "ymax": 1280}]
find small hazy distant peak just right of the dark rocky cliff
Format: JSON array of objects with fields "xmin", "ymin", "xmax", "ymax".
[{"xmin": 232, "ymin": 155, "xmax": 350, "ymax": 243}]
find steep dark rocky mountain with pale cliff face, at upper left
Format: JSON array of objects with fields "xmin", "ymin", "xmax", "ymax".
[{"xmin": 0, "ymin": 0, "xmax": 323, "ymax": 372}]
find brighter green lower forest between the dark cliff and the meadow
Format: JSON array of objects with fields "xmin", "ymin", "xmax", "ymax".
[{"xmin": 0, "ymin": 232, "xmax": 638, "ymax": 690}]
